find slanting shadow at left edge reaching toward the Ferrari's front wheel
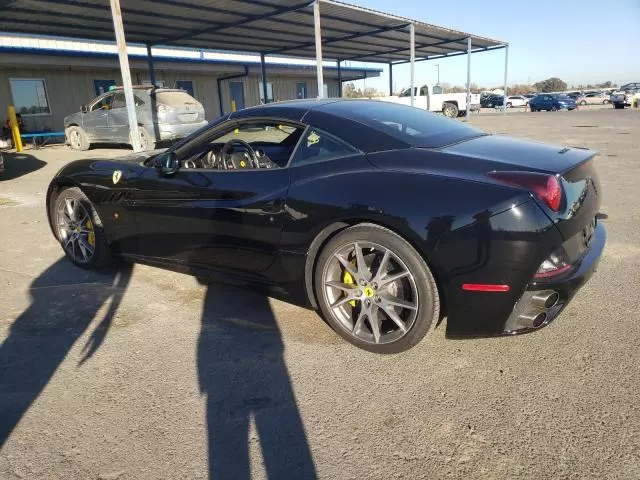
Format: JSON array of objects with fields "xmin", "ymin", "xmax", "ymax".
[{"xmin": 0, "ymin": 258, "xmax": 132, "ymax": 448}]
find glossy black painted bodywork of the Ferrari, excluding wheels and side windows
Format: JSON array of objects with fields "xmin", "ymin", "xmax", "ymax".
[{"xmin": 48, "ymin": 100, "xmax": 604, "ymax": 334}]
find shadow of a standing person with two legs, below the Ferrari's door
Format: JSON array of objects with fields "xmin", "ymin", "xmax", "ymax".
[{"xmin": 198, "ymin": 284, "xmax": 316, "ymax": 480}]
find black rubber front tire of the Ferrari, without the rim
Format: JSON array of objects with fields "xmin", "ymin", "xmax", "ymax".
[{"xmin": 49, "ymin": 187, "xmax": 113, "ymax": 270}]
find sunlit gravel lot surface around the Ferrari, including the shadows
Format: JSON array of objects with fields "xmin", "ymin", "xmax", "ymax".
[{"xmin": 0, "ymin": 108, "xmax": 640, "ymax": 480}]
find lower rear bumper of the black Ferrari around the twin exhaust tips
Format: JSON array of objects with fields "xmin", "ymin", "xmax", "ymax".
[{"xmin": 504, "ymin": 223, "xmax": 607, "ymax": 334}]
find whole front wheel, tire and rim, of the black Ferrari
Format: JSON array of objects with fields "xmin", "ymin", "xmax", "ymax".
[{"xmin": 51, "ymin": 187, "xmax": 112, "ymax": 269}]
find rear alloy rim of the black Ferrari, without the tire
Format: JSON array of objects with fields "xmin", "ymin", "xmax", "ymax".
[{"xmin": 322, "ymin": 242, "xmax": 419, "ymax": 345}]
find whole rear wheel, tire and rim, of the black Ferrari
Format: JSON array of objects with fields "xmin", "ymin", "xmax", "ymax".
[{"xmin": 314, "ymin": 224, "xmax": 440, "ymax": 353}]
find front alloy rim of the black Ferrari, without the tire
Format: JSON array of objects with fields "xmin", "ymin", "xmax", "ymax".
[{"xmin": 56, "ymin": 197, "xmax": 96, "ymax": 264}]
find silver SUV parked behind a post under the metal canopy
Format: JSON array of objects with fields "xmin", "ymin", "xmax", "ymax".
[{"xmin": 64, "ymin": 85, "xmax": 207, "ymax": 150}]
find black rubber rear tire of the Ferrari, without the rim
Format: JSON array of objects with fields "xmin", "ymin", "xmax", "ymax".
[{"xmin": 313, "ymin": 224, "xmax": 440, "ymax": 354}]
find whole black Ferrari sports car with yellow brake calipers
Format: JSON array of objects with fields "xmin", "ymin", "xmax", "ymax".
[{"xmin": 47, "ymin": 99, "xmax": 606, "ymax": 353}]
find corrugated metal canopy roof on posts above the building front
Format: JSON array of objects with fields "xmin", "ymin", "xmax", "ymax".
[{"xmin": 0, "ymin": 0, "xmax": 505, "ymax": 63}]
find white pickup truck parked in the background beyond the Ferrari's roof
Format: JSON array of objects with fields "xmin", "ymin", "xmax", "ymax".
[{"xmin": 379, "ymin": 85, "xmax": 480, "ymax": 118}]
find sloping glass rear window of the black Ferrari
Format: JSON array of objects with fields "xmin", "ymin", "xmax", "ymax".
[{"xmin": 320, "ymin": 100, "xmax": 484, "ymax": 148}]
